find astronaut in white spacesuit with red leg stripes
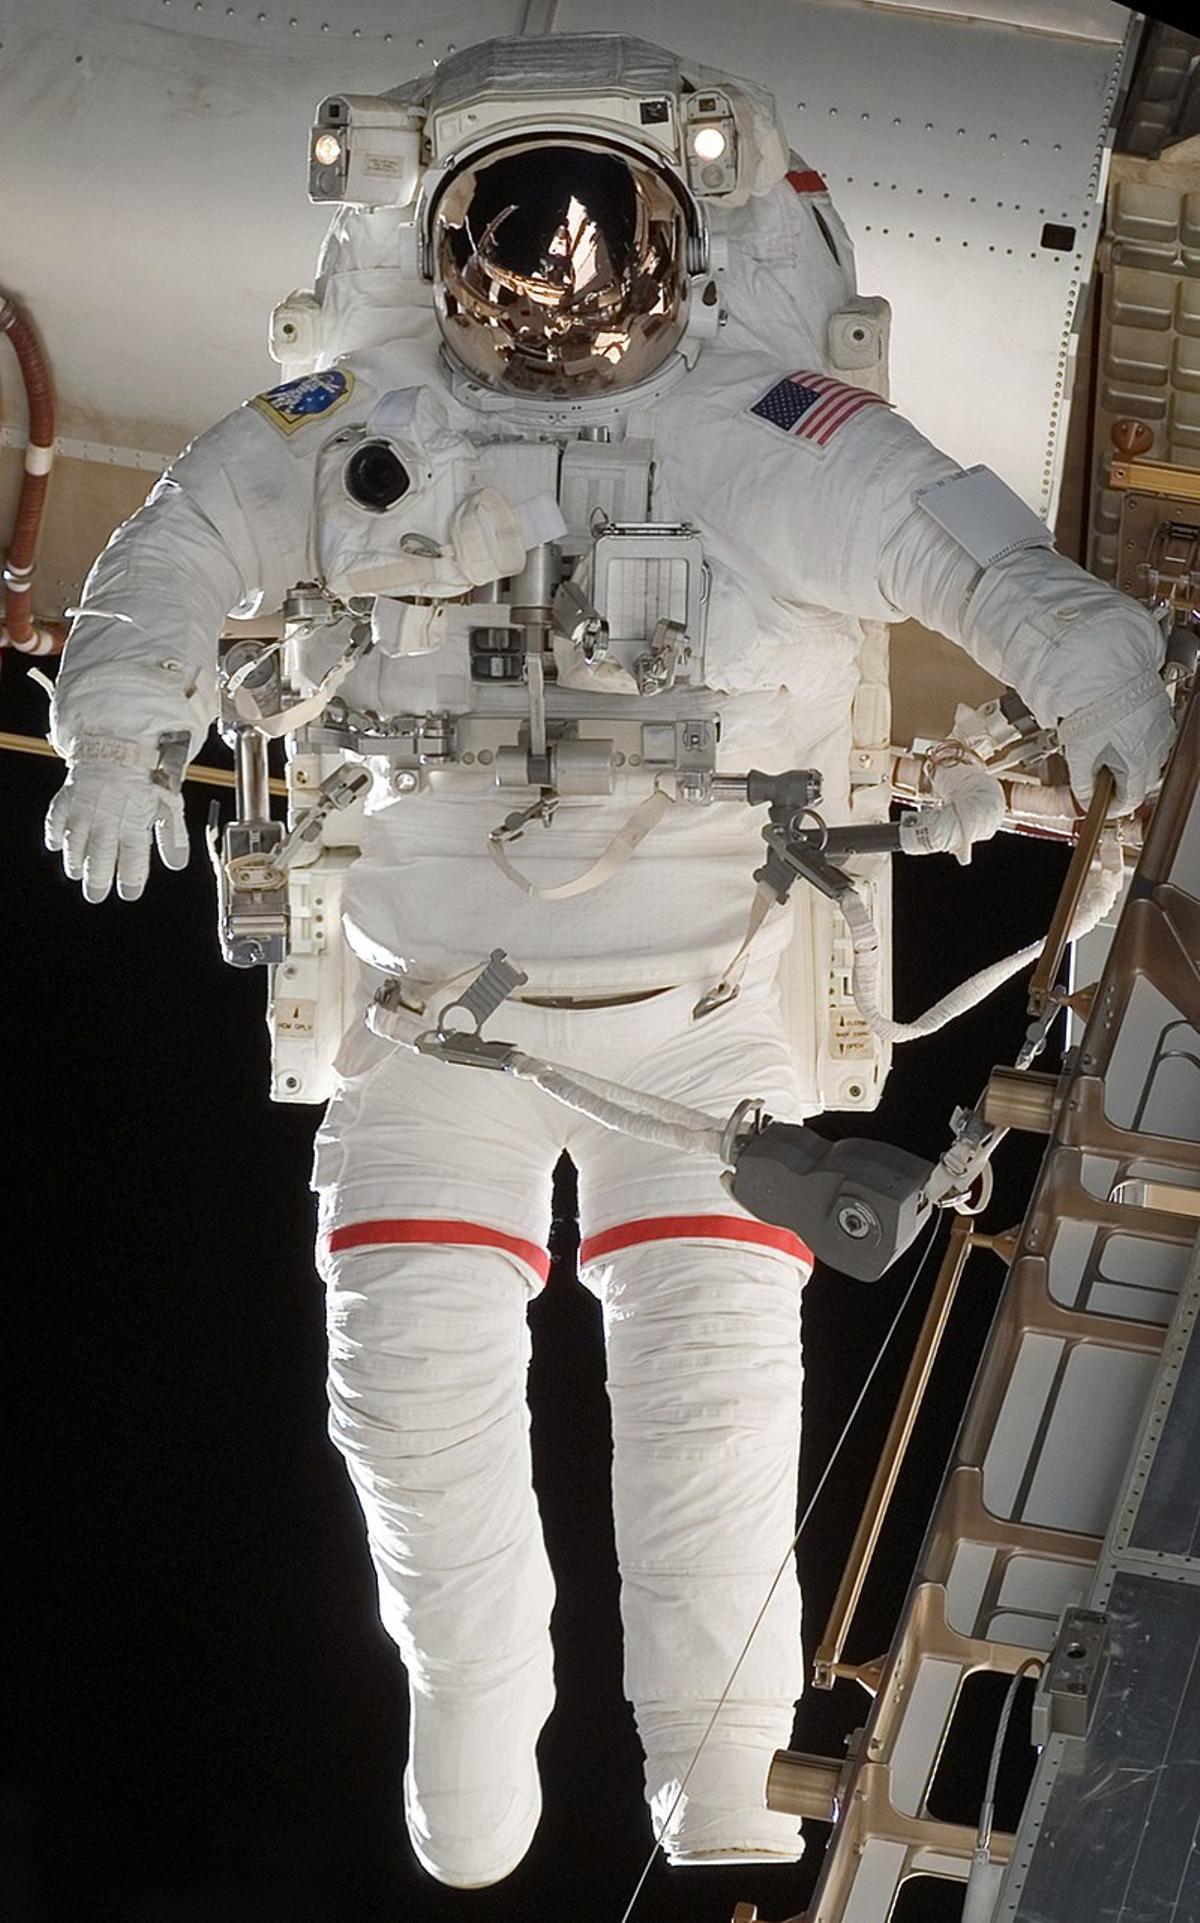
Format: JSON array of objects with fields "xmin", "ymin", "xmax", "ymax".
[{"xmin": 48, "ymin": 35, "xmax": 1171, "ymax": 1888}]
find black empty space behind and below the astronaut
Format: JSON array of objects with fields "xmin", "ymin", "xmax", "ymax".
[{"xmin": 0, "ymin": 656, "xmax": 1065, "ymax": 1923}]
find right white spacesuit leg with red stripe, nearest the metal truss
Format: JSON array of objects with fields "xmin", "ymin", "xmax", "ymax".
[{"xmin": 579, "ymin": 981, "xmax": 812, "ymax": 1863}]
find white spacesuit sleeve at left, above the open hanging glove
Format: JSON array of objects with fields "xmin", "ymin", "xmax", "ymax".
[{"xmin": 50, "ymin": 404, "xmax": 325, "ymax": 760}]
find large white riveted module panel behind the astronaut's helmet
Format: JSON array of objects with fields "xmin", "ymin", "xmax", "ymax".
[{"xmin": 0, "ymin": 0, "xmax": 1133, "ymax": 513}]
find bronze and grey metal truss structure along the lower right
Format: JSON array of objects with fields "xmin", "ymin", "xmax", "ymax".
[{"xmin": 738, "ymin": 684, "xmax": 1200, "ymax": 1923}]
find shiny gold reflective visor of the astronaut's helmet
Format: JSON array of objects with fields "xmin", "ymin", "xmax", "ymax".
[{"xmin": 431, "ymin": 137, "xmax": 688, "ymax": 398}]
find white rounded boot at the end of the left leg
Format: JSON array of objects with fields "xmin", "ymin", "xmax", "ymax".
[{"xmin": 404, "ymin": 1650, "xmax": 554, "ymax": 1890}]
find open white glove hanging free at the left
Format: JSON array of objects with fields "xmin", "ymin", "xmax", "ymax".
[{"xmin": 46, "ymin": 762, "xmax": 188, "ymax": 902}]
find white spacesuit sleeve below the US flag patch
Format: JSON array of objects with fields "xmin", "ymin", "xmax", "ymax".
[{"xmin": 844, "ymin": 408, "xmax": 1163, "ymax": 727}]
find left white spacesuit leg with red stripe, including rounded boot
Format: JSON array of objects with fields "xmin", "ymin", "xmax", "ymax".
[{"xmin": 315, "ymin": 1038, "xmax": 558, "ymax": 1888}]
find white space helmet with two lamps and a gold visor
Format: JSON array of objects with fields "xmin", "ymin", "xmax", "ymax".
[{"xmin": 310, "ymin": 33, "xmax": 787, "ymax": 402}]
